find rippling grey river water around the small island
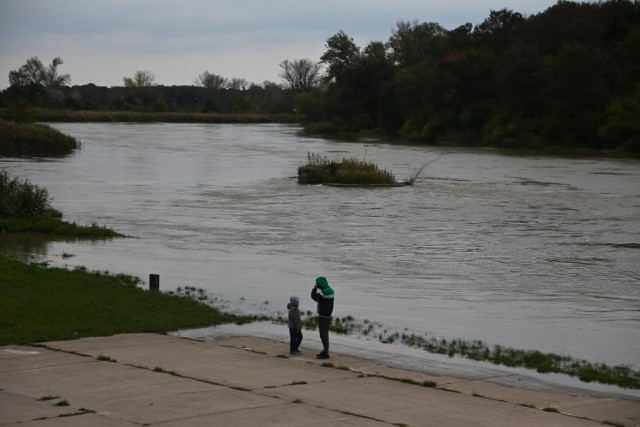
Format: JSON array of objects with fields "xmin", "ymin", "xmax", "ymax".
[{"xmin": 0, "ymin": 123, "xmax": 640, "ymax": 384}]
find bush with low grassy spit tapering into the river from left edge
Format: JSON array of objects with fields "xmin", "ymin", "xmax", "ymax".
[{"xmin": 0, "ymin": 170, "xmax": 124, "ymax": 238}]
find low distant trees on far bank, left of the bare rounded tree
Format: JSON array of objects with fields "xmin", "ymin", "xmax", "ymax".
[{"xmin": 0, "ymin": 57, "xmax": 293, "ymax": 114}]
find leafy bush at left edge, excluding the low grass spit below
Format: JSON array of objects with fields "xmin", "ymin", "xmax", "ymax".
[{"xmin": 0, "ymin": 171, "xmax": 62, "ymax": 218}]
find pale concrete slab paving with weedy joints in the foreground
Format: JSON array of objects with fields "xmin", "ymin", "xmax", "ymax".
[{"xmin": 0, "ymin": 334, "xmax": 640, "ymax": 426}]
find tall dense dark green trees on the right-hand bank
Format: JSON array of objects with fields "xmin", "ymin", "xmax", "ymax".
[{"xmin": 317, "ymin": 0, "xmax": 640, "ymax": 153}]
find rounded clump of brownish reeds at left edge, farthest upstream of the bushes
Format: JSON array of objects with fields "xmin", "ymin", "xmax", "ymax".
[{"xmin": 0, "ymin": 119, "xmax": 80, "ymax": 157}]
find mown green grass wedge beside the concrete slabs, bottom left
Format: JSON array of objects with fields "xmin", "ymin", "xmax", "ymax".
[{"xmin": 0, "ymin": 257, "xmax": 248, "ymax": 345}]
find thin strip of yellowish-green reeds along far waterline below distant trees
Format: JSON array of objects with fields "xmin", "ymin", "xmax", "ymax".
[{"xmin": 21, "ymin": 109, "xmax": 297, "ymax": 123}]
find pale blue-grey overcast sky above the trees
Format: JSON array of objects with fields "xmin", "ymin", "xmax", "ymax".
[{"xmin": 0, "ymin": 0, "xmax": 556, "ymax": 89}]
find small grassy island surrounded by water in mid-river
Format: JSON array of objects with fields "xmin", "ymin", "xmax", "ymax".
[{"xmin": 298, "ymin": 153, "xmax": 414, "ymax": 187}]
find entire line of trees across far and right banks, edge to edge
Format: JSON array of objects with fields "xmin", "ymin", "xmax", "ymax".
[{"xmin": 0, "ymin": 0, "xmax": 640, "ymax": 152}]
